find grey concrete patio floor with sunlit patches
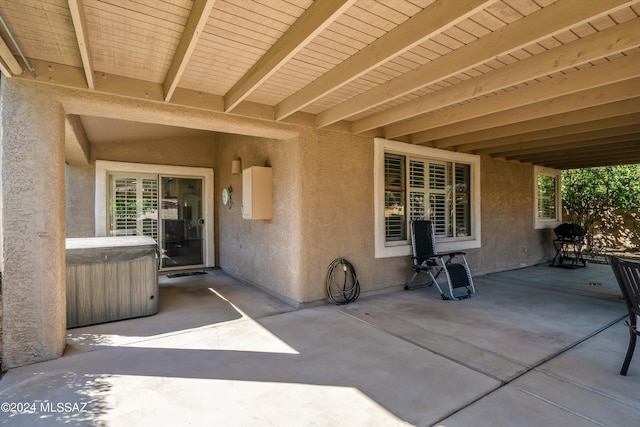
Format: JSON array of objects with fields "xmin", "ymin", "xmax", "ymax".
[{"xmin": 0, "ymin": 265, "xmax": 640, "ymax": 427}]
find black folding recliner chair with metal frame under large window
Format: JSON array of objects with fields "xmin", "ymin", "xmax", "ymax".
[{"xmin": 404, "ymin": 220, "xmax": 476, "ymax": 300}]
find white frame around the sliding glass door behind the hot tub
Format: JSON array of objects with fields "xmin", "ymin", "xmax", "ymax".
[{"xmin": 95, "ymin": 160, "xmax": 215, "ymax": 267}]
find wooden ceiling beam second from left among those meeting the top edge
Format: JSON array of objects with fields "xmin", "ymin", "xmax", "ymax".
[{"xmin": 163, "ymin": 0, "xmax": 215, "ymax": 102}]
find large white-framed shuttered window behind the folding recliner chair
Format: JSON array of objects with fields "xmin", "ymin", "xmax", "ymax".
[{"xmin": 374, "ymin": 139, "xmax": 480, "ymax": 256}]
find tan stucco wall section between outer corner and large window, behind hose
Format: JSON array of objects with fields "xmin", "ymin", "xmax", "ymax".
[{"xmin": 300, "ymin": 131, "xmax": 409, "ymax": 302}]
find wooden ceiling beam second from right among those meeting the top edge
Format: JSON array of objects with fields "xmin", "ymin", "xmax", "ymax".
[{"xmin": 276, "ymin": 0, "xmax": 496, "ymax": 122}]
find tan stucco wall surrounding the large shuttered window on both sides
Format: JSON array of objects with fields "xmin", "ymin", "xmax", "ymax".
[{"xmin": 288, "ymin": 131, "xmax": 553, "ymax": 303}]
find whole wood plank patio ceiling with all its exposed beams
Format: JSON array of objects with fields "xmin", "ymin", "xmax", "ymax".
[{"xmin": 0, "ymin": 0, "xmax": 640, "ymax": 168}]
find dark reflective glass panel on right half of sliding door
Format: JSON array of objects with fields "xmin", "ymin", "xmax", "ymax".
[{"xmin": 159, "ymin": 176, "xmax": 204, "ymax": 268}]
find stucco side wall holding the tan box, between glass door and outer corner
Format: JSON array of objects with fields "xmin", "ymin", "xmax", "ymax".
[{"xmin": 215, "ymin": 134, "xmax": 307, "ymax": 305}]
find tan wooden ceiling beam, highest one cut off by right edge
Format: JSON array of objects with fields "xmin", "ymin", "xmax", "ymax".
[{"xmin": 350, "ymin": 16, "xmax": 640, "ymax": 133}]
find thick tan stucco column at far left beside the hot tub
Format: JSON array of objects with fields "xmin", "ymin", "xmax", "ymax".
[{"xmin": 0, "ymin": 77, "xmax": 66, "ymax": 369}]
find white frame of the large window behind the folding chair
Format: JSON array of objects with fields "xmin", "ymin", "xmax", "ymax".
[{"xmin": 373, "ymin": 138, "xmax": 482, "ymax": 258}]
